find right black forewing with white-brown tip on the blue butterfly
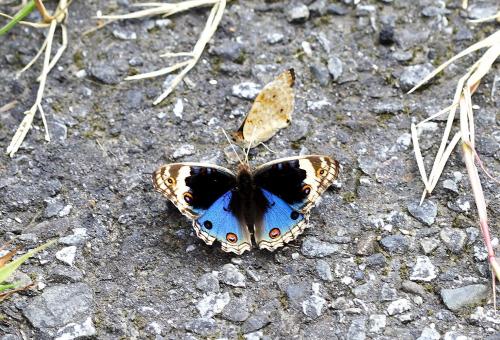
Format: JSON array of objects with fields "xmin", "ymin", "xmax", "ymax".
[{"xmin": 254, "ymin": 155, "xmax": 339, "ymax": 215}]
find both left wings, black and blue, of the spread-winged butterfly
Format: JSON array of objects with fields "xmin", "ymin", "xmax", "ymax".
[{"xmin": 153, "ymin": 163, "xmax": 251, "ymax": 254}]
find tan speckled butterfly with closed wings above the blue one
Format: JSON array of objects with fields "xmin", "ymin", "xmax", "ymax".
[{"xmin": 233, "ymin": 69, "xmax": 295, "ymax": 147}]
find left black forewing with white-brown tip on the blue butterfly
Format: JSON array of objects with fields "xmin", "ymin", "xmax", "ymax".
[{"xmin": 153, "ymin": 163, "xmax": 236, "ymax": 219}]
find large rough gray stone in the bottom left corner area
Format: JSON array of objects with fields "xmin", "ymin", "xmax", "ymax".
[{"xmin": 23, "ymin": 283, "xmax": 94, "ymax": 330}]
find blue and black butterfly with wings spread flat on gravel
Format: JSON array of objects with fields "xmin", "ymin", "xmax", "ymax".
[{"xmin": 153, "ymin": 155, "xmax": 339, "ymax": 255}]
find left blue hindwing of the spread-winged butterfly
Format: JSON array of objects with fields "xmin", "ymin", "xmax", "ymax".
[{"xmin": 193, "ymin": 191, "xmax": 252, "ymax": 255}]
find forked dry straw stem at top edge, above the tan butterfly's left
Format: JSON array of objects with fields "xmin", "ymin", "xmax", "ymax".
[{"xmin": 97, "ymin": 0, "xmax": 226, "ymax": 105}]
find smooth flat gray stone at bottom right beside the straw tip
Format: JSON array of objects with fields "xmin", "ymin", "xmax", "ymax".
[{"xmin": 441, "ymin": 284, "xmax": 489, "ymax": 311}]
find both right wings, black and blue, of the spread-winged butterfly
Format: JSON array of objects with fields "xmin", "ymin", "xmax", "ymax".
[{"xmin": 254, "ymin": 155, "xmax": 339, "ymax": 250}]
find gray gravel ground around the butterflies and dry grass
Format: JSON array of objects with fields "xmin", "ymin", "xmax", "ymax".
[{"xmin": 0, "ymin": 0, "xmax": 500, "ymax": 340}]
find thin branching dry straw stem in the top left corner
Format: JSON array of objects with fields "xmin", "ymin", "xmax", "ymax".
[{"xmin": 7, "ymin": 0, "xmax": 71, "ymax": 157}]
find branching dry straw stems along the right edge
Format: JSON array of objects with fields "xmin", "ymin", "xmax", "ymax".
[{"xmin": 410, "ymin": 31, "xmax": 500, "ymax": 306}]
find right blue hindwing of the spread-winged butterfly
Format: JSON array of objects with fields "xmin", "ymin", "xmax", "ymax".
[{"xmin": 255, "ymin": 189, "xmax": 307, "ymax": 251}]
